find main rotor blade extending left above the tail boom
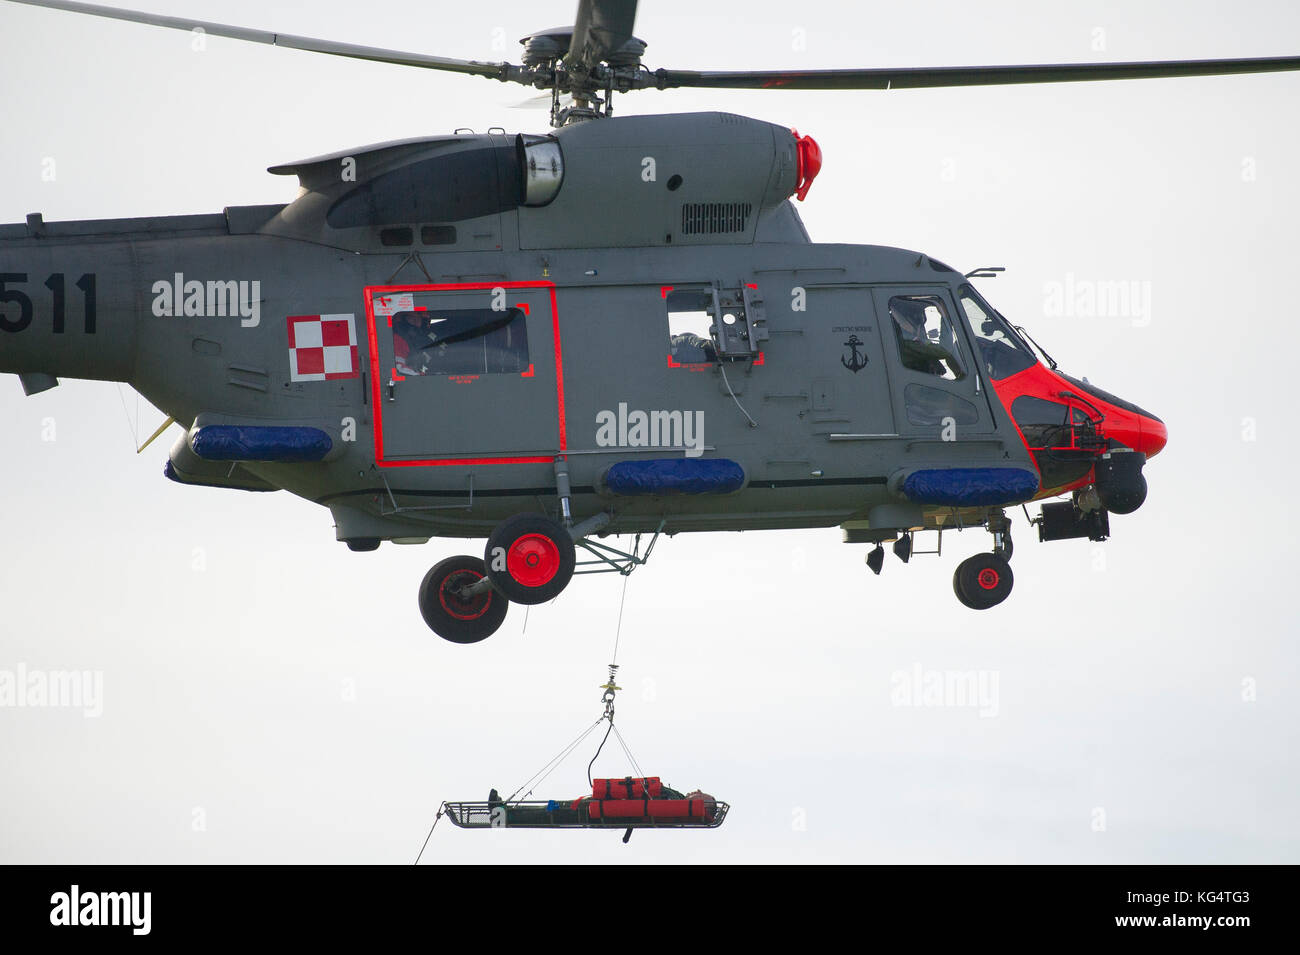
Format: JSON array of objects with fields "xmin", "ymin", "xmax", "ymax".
[{"xmin": 9, "ymin": 0, "xmax": 527, "ymax": 82}]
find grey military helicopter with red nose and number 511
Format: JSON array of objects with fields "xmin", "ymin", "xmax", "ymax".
[{"xmin": 0, "ymin": 0, "xmax": 1300, "ymax": 643}]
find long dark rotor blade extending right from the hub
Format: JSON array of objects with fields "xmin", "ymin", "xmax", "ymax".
[{"xmin": 645, "ymin": 56, "xmax": 1300, "ymax": 90}]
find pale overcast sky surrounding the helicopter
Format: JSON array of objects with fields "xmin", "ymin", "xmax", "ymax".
[{"xmin": 0, "ymin": 0, "xmax": 1300, "ymax": 863}]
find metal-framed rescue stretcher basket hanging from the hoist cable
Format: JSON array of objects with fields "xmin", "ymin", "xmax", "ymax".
[{"xmin": 442, "ymin": 798, "xmax": 731, "ymax": 829}]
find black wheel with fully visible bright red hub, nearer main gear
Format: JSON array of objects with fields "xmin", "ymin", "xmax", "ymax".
[{"xmin": 484, "ymin": 515, "xmax": 577, "ymax": 604}]
